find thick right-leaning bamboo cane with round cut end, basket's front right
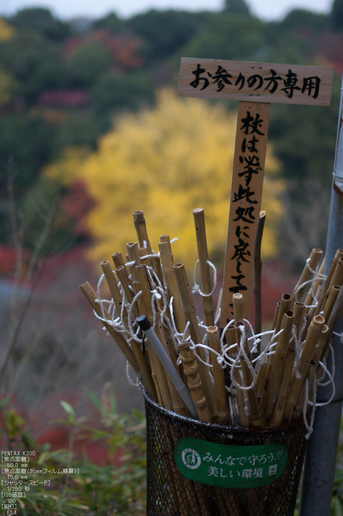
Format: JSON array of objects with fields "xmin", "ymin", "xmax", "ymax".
[{"xmin": 284, "ymin": 315, "xmax": 325, "ymax": 422}]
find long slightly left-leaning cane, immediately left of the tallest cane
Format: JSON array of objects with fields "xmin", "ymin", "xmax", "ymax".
[{"xmin": 173, "ymin": 263, "xmax": 217, "ymax": 419}]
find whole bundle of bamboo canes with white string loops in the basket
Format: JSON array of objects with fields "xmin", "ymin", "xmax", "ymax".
[{"xmin": 80, "ymin": 209, "xmax": 343, "ymax": 427}]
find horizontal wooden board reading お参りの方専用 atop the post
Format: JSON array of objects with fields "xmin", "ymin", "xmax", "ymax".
[{"xmin": 179, "ymin": 58, "xmax": 333, "ymax": 105}]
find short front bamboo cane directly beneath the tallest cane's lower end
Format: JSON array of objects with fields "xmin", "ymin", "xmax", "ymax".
[{"xmin": 207, "ymin": 326, "xmax": 229, "ymax": 425}]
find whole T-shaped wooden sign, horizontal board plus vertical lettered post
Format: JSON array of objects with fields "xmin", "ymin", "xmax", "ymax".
[{"xmin": 179, "ymin": 58, "xmax": 334, "ymax": 328}]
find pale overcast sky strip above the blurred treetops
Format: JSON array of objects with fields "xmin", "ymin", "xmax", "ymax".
[{"xmin": 0, "ymin": 0, "xmax": 333, "ymax": 20}]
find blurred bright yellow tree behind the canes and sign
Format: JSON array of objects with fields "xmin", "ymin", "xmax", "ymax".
[{"xmin": 49, "ymin": 90, "xmax": 284, "ymax": 266}]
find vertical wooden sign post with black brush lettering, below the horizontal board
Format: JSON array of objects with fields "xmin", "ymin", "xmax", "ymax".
[{"xmin": 221, "ymin": 102, "xmax": 270, "ymax": 327}]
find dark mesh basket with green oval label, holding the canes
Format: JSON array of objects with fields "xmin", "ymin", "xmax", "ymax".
[{"xmin": 144, "ymin": 393, "xmax": 306, "ymax": 516}]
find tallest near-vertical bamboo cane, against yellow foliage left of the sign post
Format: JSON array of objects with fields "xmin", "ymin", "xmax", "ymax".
[{"xmin": 193, "ymin": 208, "xmax": 214, "ymax": 326}]
